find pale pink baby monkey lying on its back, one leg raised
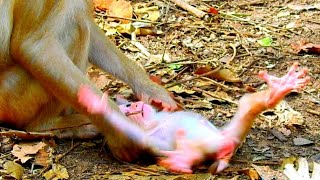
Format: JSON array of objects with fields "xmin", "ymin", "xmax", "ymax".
[{"xmin": 79, "ymin": 63, "xmax": 310, "ymax": 173}]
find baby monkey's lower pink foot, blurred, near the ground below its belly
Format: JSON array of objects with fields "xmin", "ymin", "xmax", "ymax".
[{"xmin": 158, "ymin": 130, "xmax": 203, "ymax": 173}]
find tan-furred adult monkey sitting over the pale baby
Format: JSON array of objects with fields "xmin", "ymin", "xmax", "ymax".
[{"xmin": 0, "ymin": 0, "xmax": 176, "ymax": 160}]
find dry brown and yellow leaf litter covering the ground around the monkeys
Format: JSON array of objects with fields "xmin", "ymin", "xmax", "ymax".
[{"xmin": 0, "ymin": 0, "xmax": 320, "ymax": 179}]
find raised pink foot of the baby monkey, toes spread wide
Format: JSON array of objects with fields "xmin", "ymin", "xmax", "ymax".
[{"xmin": 259, "ymin": 63, "xmax": 310, "ymax": 107}]
